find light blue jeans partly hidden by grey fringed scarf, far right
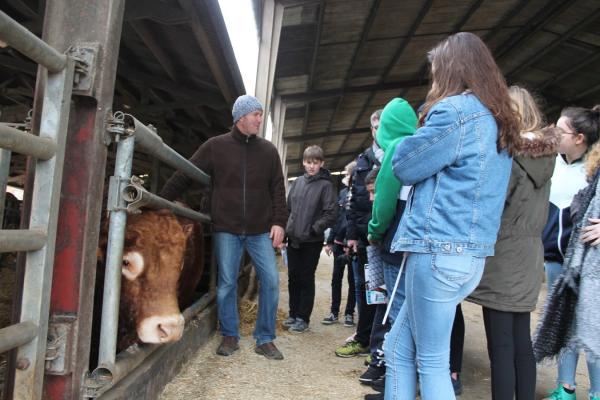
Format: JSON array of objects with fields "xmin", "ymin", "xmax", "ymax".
[{"xmin": 545, "ymin": 261, "xmax": 600, "ymax": 396}]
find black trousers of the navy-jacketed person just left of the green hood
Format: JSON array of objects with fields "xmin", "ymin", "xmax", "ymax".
[{"xmin": 354, "ymin": 247, "xmax": 377, "ymax": 346}]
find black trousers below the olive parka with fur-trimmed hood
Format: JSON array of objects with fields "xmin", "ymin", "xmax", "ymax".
[{"xmin": 483, "ymin": 307, "xmax": 536, "ymax": 400}]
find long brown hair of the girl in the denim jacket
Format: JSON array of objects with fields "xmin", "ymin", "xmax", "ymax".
[{"xmin": 420, "ymin": 32, "xmax": 520, "ymax": 155}]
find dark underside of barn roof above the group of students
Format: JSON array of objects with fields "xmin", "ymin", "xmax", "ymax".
[{"xmin": 274, "ymin": 0, "xmax": 600, "ymax": 176}]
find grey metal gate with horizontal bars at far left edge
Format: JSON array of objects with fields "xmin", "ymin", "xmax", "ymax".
[{"xmin": 0, "ymin": 11, "xmax": 75, "ymax": 399}]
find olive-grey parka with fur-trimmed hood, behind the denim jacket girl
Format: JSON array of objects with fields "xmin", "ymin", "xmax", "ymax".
[{"xmin": 468, "ymin": 128, "xmax": 560, "ymax": 312}]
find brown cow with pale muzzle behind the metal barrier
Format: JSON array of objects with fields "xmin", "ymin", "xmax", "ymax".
[{"xmin": 95, "ymin": 210, "xmax": 204, "ymax": 350}]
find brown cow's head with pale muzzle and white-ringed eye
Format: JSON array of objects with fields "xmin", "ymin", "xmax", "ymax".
[{"xmin": 120, "ymin": 210, "xmax": 192, "ymax": 343}]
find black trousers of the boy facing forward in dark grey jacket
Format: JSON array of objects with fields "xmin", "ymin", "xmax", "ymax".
[{"xmin": 287, "ymin": 242, "xmax": 323, "ymax": 323}]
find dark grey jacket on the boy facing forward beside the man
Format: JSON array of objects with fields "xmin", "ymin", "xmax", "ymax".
[{"xmin": 285, "ymin": 169, "xmax": 337, "ymax": 246}]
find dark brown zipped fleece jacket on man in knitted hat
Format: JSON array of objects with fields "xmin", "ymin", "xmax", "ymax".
[{"xmin": 160, "ymin": 126, "xmax": 288, "ymax": 235}]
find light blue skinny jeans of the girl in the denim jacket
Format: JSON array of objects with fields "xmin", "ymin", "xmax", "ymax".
[{"xmin": 383, "ymin": 253, "xmax": 485, "ymax": 400}]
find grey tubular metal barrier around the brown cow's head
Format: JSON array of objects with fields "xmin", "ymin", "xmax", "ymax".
[{"xmin": 84, "ymin": 112, "xmax": 216, "ymax": 398}]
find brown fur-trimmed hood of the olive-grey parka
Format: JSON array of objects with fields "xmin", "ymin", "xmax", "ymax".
[{"xmin": 514, "ymin": 126, "xmax": 560, "ymax": 188}]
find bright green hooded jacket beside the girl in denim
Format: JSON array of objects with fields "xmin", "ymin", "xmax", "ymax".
[{"xmin": 369, "ymin": 98, "xmax": 418, "ymax": 242}]
